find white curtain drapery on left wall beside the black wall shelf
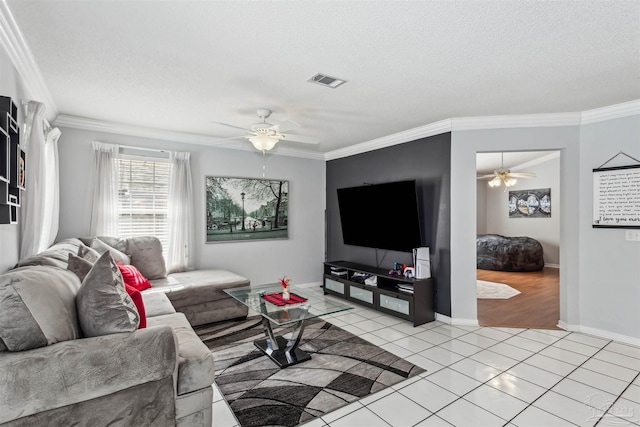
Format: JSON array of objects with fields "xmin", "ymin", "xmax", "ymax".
[{"xmin": 20, "ymin": 101, "xmax": 61, "ymax": 259}]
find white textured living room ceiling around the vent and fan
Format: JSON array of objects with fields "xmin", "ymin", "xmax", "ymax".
[{"xmin": 8, "ymin": 0, "xmax": 640, "ymax": 153}]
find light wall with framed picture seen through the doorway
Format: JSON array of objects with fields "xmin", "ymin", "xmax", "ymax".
[{"xmin": 478, "ymin": 156, "xmax": 562, "ymax": 266}]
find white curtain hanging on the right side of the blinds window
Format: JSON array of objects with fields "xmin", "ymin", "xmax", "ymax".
[{"xmin": 167, "ymin": 152, "xmax": 193, "ymax": 273}]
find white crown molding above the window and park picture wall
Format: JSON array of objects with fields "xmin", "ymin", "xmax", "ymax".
[{"xmin": 53, "ymin": 114, "xmax": 324, "ymax": 160}]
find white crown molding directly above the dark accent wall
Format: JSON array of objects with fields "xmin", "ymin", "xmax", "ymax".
[{"xmin": 324, "ymin": 119, "xmax": 451, "ymax": 160}]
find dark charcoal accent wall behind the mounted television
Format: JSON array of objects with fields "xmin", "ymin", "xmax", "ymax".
[{"xmin": 327, "ymin": 132, "xmax": 450, "ymax": 316}]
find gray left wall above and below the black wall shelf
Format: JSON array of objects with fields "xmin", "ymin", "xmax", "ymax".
[{"xmin": 0, "ymin": 48, "xmax": 29, "ymax": 272}]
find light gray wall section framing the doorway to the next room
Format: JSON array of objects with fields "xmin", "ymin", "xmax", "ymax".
[{"xmin": 451, "ymin": 126, "xmax": 580, "ymax": 324}]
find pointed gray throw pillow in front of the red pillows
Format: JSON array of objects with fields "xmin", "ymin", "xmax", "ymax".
[{"xmin": 76, "ymin": 251, "xmax": 140, "ymax": 337}]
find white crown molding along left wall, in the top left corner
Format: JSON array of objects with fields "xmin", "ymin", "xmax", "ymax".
[{"xmin": 0, "ymin": 0, "xmax": 58, "ymax": 120}]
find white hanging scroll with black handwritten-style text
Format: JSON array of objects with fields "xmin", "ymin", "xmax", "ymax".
[{"xmin": 593, "ymin": 165, "xmax": 640, "ymax": 228}]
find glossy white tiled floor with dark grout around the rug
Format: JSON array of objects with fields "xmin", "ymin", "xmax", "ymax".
[{"xmin": 213, "ymin": 294, "xmax": 640, "ymax": 427}]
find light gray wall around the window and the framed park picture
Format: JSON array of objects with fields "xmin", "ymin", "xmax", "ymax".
[{"xmin": 58, "ymin": 128, "xmax": 325, "ymax": 284}]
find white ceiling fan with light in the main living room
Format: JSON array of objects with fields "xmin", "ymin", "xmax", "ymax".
[{"xmin": 213, "ymin": 108, "xmax": 318, "ymax": 152}]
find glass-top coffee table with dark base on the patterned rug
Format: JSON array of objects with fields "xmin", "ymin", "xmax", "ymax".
[{"xmin": 224, "ymin": 283, "xmax": 353, "ymax": 368}]
